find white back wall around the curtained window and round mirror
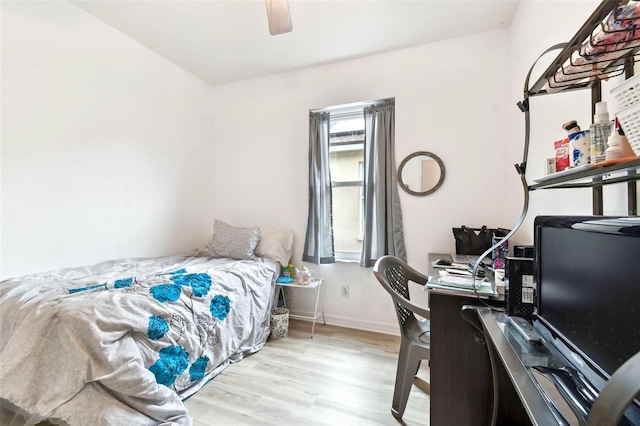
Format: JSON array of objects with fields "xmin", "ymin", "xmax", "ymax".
[{"xmin": 212, "ymin": 30, "xmax": 515, "ymax": 333}]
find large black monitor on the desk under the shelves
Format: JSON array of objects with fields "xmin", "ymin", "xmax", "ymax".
[{"xmin": 534, "ymin": 216, "xmax": 640, "ymax": 420}]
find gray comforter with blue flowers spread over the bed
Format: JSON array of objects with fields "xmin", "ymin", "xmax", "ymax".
[{"xmin": 0, "ymin": 256, "xmax": 278, "ymax": 425}]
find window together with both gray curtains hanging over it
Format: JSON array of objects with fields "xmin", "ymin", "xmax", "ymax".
[{"xmin": 302, "ymin": 99, "xmax": 406, "ymax": 268}]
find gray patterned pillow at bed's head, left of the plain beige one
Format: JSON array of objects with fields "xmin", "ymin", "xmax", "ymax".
[{"xmin": 209, "ymin": 219, "xmax": 260, "ymax": 260}]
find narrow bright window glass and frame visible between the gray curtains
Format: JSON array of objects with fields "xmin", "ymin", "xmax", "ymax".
[{"xmin": 329, "ymin": 111, "xmax": 364, "ymax": 261}]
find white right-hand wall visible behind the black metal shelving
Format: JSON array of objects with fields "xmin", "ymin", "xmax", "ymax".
[{"xmin": 507, "ymin": 0, "xmax": 640, "ymax": 244}]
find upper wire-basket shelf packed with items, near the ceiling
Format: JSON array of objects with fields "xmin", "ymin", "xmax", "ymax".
[{"xmin": 527, "ymin": 0, "xmax": 640, "ymax": 96}]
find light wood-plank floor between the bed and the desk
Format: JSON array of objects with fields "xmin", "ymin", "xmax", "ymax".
[{"xmin": 185, "ymin": 320, "xmax": 429, "ymax": 426}]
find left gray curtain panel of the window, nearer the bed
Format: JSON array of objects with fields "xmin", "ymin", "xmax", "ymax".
[{"xmin": 302, "ymin": 112, "xmax": 336, "ymax": 265}]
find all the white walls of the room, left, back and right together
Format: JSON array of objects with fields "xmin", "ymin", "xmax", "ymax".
[{"xmin": 0, "ymin": 0, "xmax": 624, "ymax": 333}]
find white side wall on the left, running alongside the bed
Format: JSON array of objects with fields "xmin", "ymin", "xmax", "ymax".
[{"xmin": 0, "ymin": 1, "xmax": 214, "ymax": 278}]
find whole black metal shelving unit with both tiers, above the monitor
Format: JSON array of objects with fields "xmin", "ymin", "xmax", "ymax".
[{"xmin": 516, "ymin": 0, "xmax": 640, "ymax": 216}]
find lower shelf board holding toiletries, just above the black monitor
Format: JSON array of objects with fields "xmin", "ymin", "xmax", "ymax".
[{"xmin": 529, "ymin": 158, "xmax": 640, "ymax": 191}]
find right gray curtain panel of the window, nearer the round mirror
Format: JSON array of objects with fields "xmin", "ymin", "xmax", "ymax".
[{"xmin": 360, "ymin": 101, "xmax": 407, "ymax": 268}]
